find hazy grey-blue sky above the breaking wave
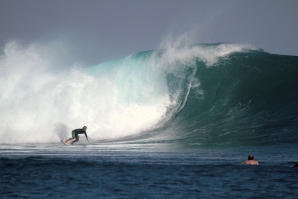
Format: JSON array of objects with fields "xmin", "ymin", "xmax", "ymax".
[{"xmin": 0, "ymin": 0, "xmax": 298, "ymax": 65}]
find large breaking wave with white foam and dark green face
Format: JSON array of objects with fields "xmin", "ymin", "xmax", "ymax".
[{"xmin": 0, "ymin": 43, "xmax": 298, "ymax": 145}]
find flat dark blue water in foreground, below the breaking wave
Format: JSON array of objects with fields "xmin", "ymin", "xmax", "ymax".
[{"xmin": 0, "ymin": 143, "xmax": 298, "ymax": 198}]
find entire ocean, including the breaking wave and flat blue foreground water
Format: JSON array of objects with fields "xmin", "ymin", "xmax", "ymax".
[{"xmin": 0, "ymin": 43, "xmax": 298, "ymax": 198}]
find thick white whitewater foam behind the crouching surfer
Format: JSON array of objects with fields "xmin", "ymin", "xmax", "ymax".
[{"xmin": 0, "ymin": 43, "xmax": 171, "ymax": 143}]
